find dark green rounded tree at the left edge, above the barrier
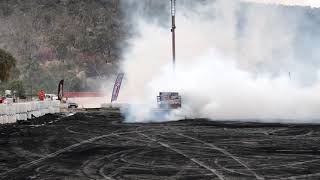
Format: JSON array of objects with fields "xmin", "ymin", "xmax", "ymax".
[{"xmin": 0, "ymin": 49, "xmax": 17, "ymax": 81}]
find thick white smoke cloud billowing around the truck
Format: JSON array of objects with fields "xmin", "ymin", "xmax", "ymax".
[{"xmin": 115, "ymin": 0, "xmax": 320, "ymax": 122}]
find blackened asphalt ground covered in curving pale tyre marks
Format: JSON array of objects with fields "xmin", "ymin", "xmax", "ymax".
[{"xmin": 0, "ymin": 110, "xmax": 320, "ymax": 180}]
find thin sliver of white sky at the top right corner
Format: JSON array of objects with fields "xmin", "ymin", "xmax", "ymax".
[{"xmin": 242, "ymin": 0, "xmax": 320, "ymax": 8}]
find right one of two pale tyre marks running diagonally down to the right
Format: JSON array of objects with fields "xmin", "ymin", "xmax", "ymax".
[{"xmin": 174, "ymin": 132, "xmax": 264, "ymax": 180}]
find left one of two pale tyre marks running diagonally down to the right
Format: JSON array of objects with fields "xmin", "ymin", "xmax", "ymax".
[{"xmin": 138, "ymin": 132, "xmax": 225, "ymax": 180}]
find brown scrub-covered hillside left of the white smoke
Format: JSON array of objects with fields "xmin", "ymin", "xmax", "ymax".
[{"xmin": 0, "ymin": 0, "xmax": 126, "ymax": 94}]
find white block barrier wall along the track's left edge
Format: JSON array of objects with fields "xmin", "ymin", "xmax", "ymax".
[{"xmin": 0, "ymin": 101, "xmax": 60, "ymax": 124}]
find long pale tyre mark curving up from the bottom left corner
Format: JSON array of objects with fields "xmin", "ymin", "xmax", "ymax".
[{"xmin": 0, "ymin": 130, "xmax": 145, "ymax": 177}]
